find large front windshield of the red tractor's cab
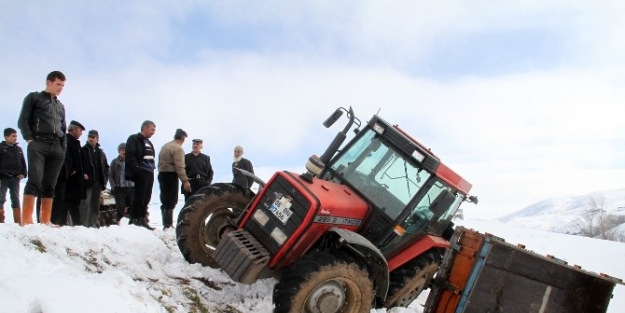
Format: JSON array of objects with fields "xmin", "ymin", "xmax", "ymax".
[{"xmin": 331, "ymin": 129, "xmax": 430, "ymax": 219}]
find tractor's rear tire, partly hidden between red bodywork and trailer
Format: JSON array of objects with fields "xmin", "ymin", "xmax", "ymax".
[{"xmin": 384, "ymin": 251, "xmax": 441, "ymax": 308}]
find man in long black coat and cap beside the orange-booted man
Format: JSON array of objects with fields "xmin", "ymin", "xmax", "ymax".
[{"xmin": 52, "ymin": 121, "xmax": 87, "ymax": 226}]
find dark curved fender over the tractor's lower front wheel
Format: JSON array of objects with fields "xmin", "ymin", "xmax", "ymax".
[{"xmin": 329, "ymin": 227, "xmax": 389, "ymax": 301}]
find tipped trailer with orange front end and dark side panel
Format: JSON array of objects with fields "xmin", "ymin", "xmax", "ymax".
[{"xmin": 424, "ymin": 227, "xmax": 623, "ymax": 313}]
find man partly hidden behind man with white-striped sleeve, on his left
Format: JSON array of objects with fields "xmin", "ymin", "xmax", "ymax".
[{"xmin": 109, "ymin": 142, "xmax": 135, "ymax": 222}]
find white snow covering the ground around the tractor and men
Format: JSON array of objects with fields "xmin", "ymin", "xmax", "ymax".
[{"xmin": 0, "ymin": 204, "xmax": 625, "ymax": 313}]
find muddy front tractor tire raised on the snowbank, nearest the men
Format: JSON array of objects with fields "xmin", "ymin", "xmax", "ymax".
[{"xmin": 176, "ymin": 183, "xmax": 254, "ymax": 268}]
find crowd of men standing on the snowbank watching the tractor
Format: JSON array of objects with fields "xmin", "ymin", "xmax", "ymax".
[{"xmin": 0, "ymin": 71, "xmax": 254, "ymax": 230}]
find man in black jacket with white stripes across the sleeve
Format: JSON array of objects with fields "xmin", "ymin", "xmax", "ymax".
[{"xmin": 125, "ymin": 120, "xmax": 156, "ymax": 230}]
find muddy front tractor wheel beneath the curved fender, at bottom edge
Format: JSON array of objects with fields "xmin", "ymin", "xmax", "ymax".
[{"xmin": 273, "ymin": 251, "xmax": 374, "ymax": 313}]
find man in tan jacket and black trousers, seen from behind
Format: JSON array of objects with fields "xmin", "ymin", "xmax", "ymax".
[{"xmin": 158, "ymin": 128, "xmax": 191, "ymax": 230}]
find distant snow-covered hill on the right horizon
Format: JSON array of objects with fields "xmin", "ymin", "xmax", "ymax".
[{"xmin": 497, "ymin": 188, "xmax": 625, "ymax": 234}]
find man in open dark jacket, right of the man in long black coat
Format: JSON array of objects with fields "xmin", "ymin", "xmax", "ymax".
[{"xmin": 80, "ymin": 130, "xmax": 109, "ymax": 227}]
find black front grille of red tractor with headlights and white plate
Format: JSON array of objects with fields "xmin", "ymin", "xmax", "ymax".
[{"xmin": 243, "ymin": 176, "xmax": 310, "ymax": 255}]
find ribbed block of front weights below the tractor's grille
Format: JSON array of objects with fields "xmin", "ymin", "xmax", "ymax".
[{"xmin": 214, "ymin": 229, "xmax": 271, "ymax": 284}]
